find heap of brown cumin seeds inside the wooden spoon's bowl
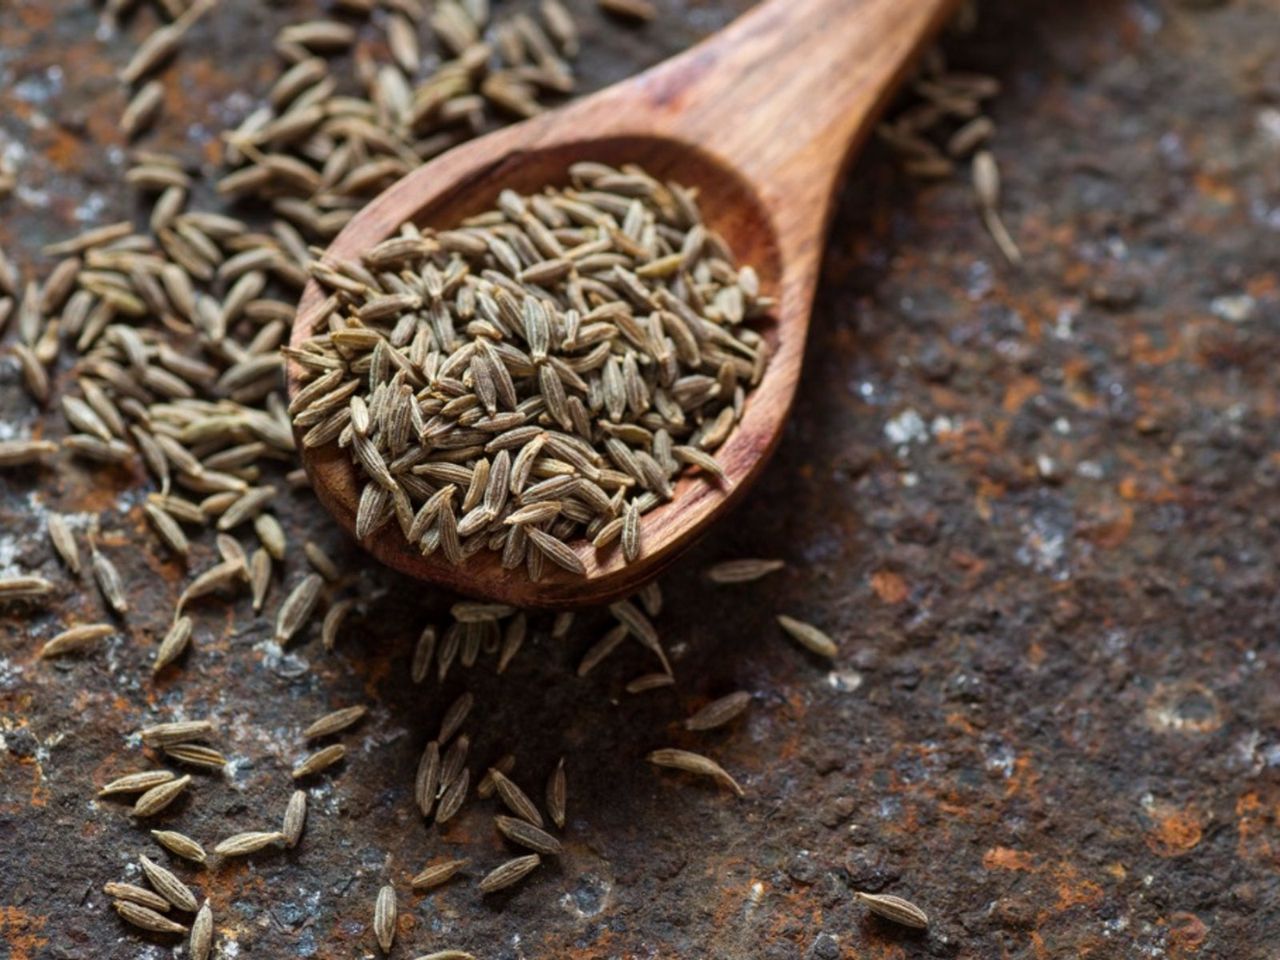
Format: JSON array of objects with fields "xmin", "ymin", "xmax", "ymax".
[{"xmin": 288, "ymin": 163, "xmax": 772, "ymax": 581}]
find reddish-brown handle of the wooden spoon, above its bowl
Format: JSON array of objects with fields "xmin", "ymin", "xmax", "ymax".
[{"xmin": 619, "ymin": 0, "xmax": 957, "ymax": 213}]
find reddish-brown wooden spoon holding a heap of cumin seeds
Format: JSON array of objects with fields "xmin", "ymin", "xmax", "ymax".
[{"xmin": 288, "ymin": 0, "xmax": 955, "ymax": 607}]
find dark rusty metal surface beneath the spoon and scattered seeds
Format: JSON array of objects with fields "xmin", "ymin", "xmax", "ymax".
[{"xmin": 0, "ymin": 0, "xmax": 1280, "ymax": 960}]
